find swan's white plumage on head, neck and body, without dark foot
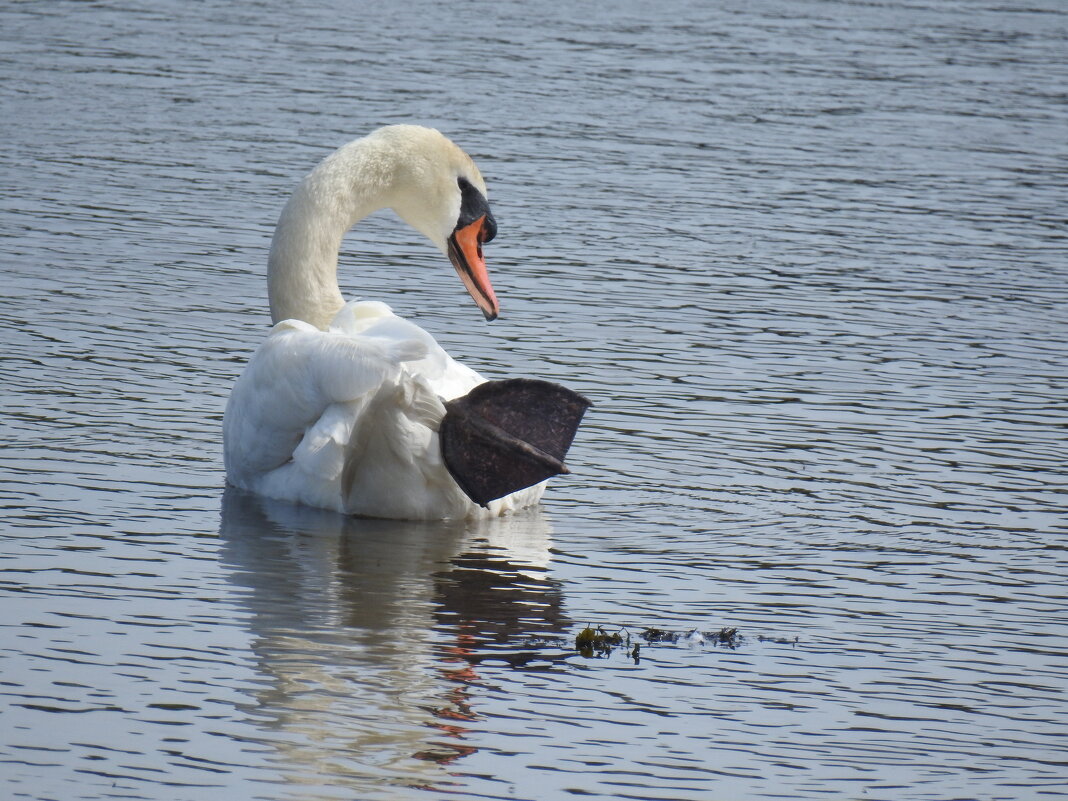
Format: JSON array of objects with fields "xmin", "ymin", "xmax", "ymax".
[{"xmin": 223, "ymin": 126, "xmax": 544, "ymax": 519}]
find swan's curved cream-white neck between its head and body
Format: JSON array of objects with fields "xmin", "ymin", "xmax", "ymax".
[{"xmin": 267, "ymin": 145, "xmax": 393, "ymax": 329}]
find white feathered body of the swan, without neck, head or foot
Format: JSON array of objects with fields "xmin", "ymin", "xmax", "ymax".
[{"xmin": 223, "ymin": 304, "xmax": 541, "ymax": 519}]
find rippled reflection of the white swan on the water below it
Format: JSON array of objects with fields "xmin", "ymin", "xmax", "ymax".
[{"xmin": 220, "ymin": 488, "xmax": 569, "ymax": 799}]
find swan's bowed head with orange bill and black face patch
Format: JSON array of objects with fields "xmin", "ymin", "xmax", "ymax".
[{"xmin": 365, "ymin": 125, "xmax": 500, "ymax": 320}]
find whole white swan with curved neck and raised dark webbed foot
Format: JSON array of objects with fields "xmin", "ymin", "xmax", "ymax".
[{"xmin": 223, "ymin": 125, "xmax": 588, "ymax": 520}]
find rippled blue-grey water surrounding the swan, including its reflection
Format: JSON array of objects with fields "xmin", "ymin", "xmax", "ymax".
[{"xmin": 0, "ymin": 0, "xmax": 1068, "ymax": 800}]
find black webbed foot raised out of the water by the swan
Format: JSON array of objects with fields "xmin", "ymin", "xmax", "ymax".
[{"xmin": 439, "ymin": 378, "xmax": 593, "ymax": 506}]
